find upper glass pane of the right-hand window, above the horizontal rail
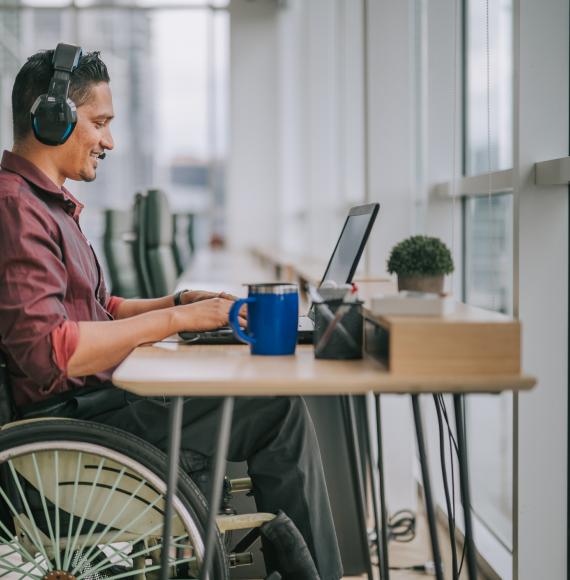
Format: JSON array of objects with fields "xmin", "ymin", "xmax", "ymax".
[{"xmin": 465, "ymin": 0, "xmax": 513, "ymax": 175}]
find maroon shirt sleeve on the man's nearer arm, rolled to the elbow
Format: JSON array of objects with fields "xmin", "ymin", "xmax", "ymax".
[{"xmin": 0, "ymin": 197, "xmax": 68, "ymax": 394}]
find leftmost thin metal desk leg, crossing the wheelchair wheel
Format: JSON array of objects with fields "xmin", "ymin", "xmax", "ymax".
[{"xmin": 160, "ymin": 397, "xmax": 184, "ymax": 580}]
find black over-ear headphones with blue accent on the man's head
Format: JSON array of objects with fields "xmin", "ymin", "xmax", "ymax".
[{"xmin": 30, "ymin": 43, "xmax": 83, "ymax": 145}]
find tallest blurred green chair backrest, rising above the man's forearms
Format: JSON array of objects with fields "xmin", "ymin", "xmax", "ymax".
[{"xmin": 145, "ymin": 189, "xmax": 178, "ymax": 297}]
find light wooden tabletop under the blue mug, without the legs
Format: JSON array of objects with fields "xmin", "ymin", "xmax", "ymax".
[{"xmin": 113, "ymin": 344, "xmax": 535, "ymax": 396}]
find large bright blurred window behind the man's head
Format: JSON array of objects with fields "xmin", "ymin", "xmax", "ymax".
[{"xmin": 0, "ymin": 0, "xmax": 229, "ymax": 255}]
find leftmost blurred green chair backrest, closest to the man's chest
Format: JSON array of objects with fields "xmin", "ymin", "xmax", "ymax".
[{"xmin": 103, "ymin": 209, "xmax": 143, "ymax": 298}]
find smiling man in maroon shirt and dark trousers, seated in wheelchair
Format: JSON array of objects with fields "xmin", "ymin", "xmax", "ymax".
[{"xmin": 0, "ymin": 51, "xmax": 342, "ymax": 580}]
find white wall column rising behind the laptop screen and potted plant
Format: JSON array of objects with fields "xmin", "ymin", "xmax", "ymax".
[{"xmin": 367, "ymin": 0, "xmax": 416, "ymax": 512}]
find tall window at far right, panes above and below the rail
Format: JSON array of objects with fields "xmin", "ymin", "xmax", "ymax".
[{"xmin": 463, "ymin": 0, "xmax": 513, "ymax": 550}]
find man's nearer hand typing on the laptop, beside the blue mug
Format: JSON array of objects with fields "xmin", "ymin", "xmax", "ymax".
[{"xmin": 173, "ymin": 292, "xmax": 247, "ymax": 332}]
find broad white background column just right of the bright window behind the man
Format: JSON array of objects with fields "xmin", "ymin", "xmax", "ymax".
[{"xmin": 226, "ymin": 0, "xmax": 279, "ymax": 248}]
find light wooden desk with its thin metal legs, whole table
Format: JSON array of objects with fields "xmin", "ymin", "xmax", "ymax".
[{"xmin": 113, "ymin": 344, "xmax": 535, "ymax": 580}]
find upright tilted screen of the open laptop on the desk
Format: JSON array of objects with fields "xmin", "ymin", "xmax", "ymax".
[{"xmin": 321, "ymin": 203, "xmax": 379, "ymax": 285}]
